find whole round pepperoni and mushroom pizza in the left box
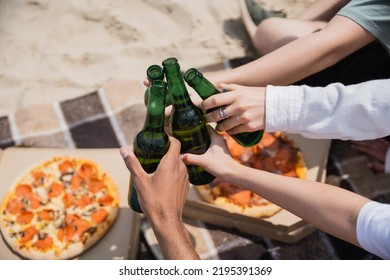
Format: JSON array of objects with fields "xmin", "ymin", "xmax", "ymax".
[{"xmin": 0, "ymin": 156, "xmax": 119, "ymax": 259}]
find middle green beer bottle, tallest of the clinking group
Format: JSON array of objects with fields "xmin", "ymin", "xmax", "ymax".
[{"xmin": 162, "ymin": 57, "xmax": 215, "ymax": 185}]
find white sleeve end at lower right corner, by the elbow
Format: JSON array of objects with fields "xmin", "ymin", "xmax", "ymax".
[{"xmin": 356, "ymin": 201, "xmax": 390, "ymax": 259}]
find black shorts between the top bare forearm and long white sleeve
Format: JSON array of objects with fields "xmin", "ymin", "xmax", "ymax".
[{"xmin": 293, "ymin": 41, "xmax": 390, "ymax": 86}]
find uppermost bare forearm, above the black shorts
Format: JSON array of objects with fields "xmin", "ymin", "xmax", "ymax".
[{"xmin": 216, "ymin": 16, "xmax": 374, "ymax": 86}]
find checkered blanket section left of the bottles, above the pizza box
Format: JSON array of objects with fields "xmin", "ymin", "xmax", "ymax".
[{"xmin": 0, "ymin": 78, "xmax": 146, "ymax": 149}]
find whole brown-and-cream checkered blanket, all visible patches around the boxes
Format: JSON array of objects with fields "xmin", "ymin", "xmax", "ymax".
[{"xmin": 0, "ymin": 58, "xmax": 390, "ymax": 259}]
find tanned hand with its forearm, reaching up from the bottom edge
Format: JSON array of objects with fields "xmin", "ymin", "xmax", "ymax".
[{"xmin": 120, "ymin": 136, "xmax": 199, "ymax": 259}]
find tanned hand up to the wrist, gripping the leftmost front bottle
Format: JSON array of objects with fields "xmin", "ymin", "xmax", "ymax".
[{"xmin": 120, "ymin": 136, "xmax": 190, "ymax": 224}]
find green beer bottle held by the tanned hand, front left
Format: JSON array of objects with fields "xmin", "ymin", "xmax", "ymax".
[{"xmin": 128, "ymin": 80, "xmax": 169, "ymax": 213}]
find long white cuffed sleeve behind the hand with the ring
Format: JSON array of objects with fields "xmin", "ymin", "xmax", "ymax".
[{"xmin": 265, "ymin": 79, "xmax": 390, "ymax": 140}]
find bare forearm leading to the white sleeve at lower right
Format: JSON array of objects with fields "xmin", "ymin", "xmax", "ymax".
[{"xmin": 226, "ymin": 164, "xmax": 369, "ymax": 245}]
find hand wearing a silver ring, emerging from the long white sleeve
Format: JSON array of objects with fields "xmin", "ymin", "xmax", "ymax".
[{"xmin": 202, "ymin": 83, "xmax": 265, "ymax": 134}]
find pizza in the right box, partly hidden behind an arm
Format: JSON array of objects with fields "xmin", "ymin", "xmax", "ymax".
[{"xmin": 195, "ymin": 132, "xmax": 307, "ymax": 218}]
